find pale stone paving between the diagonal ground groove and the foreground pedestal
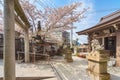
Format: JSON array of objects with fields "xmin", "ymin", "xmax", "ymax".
[{"xmin": 53, "ymin": 57, "xmax": 90, "ymax": 80}]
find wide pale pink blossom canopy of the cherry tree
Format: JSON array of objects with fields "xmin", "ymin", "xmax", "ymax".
[{"xmin": 21, "ymin": 0, "xmax": 88, "ymax": 31}]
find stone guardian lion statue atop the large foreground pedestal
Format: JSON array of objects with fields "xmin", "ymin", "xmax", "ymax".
[{"xmin": 91, "ymin": 39, "xmax": 104, "ymax": 52}]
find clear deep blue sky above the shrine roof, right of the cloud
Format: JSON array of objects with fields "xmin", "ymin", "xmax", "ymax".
[{"xmin": 93, "ymin": 0, "xmax": 120, "ymax": 21}]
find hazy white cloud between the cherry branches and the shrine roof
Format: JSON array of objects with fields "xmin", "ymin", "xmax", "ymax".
[{"xmin": 77, "ymin": 0, "xmax": 96, "ymax": 30}]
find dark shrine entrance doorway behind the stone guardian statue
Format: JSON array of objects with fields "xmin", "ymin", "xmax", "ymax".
[{"xmin": 104, "ymin": 36, "xmax": 116, "ymax": 58}]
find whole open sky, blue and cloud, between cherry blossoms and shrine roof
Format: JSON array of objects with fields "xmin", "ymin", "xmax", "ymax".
[{"xmin": 50, "ymin": 0, "xmax": 120, "ymax": 43}]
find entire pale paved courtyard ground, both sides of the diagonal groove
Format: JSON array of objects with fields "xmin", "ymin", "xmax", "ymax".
[{"xmin": 0, "ymin": 56, "xmax": 120, "ymax": 80}]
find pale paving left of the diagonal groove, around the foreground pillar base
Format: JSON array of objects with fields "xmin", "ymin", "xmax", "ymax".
[{"xmin": 0, "ymin": 60, "xmax": 58, "ymax": 80}]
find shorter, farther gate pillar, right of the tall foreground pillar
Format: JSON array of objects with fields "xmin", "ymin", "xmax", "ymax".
[{"xmin": 24, "ymin": 29, "xmax": 30, "ymax": 62}]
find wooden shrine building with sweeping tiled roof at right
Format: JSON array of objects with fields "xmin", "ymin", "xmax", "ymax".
[{"xmin": 77, "ymin": 10, "xmax": 120, "ymax": 66}]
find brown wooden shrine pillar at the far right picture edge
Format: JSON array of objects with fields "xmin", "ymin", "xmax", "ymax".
[{"xmin": 116, "ymin": 30, "xmax": 120, "ymax": 66}]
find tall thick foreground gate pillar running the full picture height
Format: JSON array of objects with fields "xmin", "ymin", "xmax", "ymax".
[{"xmin": 3, "ymin": 0, "xmax": 15, "ymax": 80}]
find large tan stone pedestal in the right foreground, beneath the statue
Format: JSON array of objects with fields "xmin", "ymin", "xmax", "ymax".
[{"xmin": 86, "ymin": 50, "xmax": 110, "ymax": 80}]
